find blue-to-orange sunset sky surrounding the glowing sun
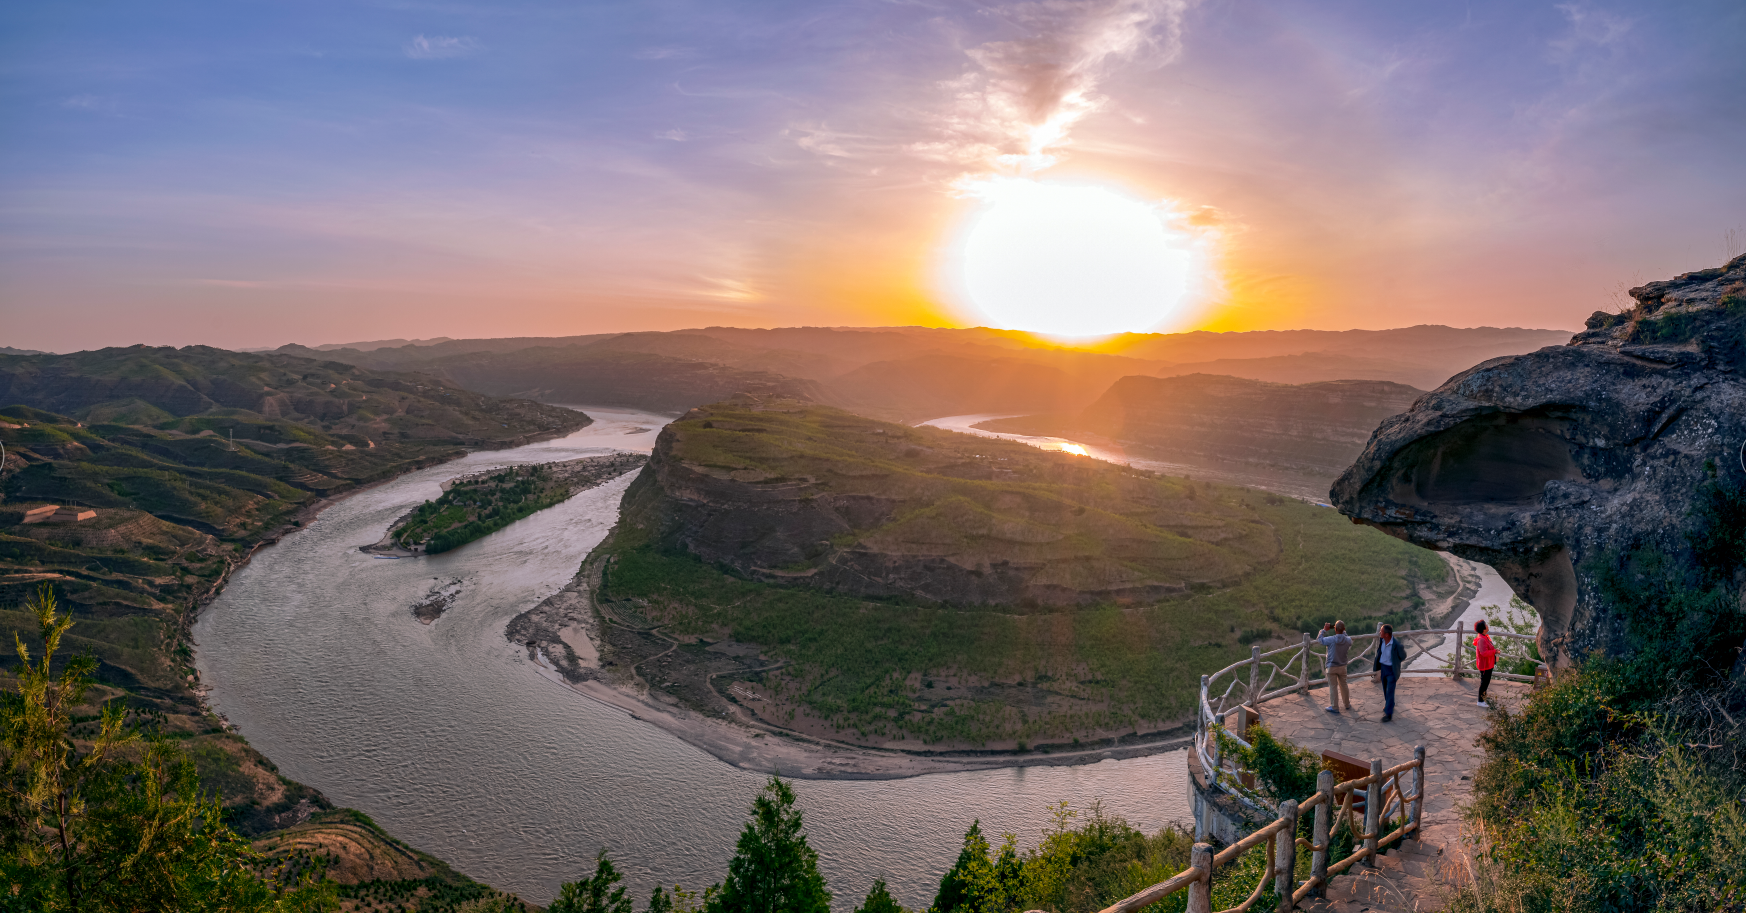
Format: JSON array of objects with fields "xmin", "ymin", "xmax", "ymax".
[{"xmin": 0, "ymin": 0, "xmax": 1746, "ymax": 351}]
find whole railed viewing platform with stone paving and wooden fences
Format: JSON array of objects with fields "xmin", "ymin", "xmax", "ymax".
[{"xmin": 1103, "ymin": 623, "xmax": 1550, "ymax": 913}]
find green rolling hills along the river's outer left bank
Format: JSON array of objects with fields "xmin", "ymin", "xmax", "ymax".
[{"xmin": 0, "ymin": 346, "xmax": 590, "ymax": 896}]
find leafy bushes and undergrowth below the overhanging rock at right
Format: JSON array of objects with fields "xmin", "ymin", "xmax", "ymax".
[{"xmin": 1454, "ymin": 482, "xmax": 1746, "ymax": 913}]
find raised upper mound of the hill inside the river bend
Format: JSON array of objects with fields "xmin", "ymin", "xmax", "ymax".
[{"xmin": 625, "ymin": 402, "xmax": 1280, "ymax": 606}]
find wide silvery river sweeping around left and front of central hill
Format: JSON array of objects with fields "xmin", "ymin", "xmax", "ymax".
[{"xmin": 194, "ymin": 407, "xmax": 1189, "ymax": 910}]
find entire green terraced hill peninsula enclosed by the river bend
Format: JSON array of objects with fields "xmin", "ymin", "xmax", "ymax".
[{"xmin": 579, "ymin": 398, "xmax": 1456, "ymax": 751}]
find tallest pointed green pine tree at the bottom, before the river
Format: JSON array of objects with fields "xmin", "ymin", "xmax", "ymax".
[{"xmin": 705, "ymin": 777, "xmax": 831, "ymax": 913}]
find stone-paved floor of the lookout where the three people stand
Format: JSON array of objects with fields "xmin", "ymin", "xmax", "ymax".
[{"xmin": 1261, "ymin": 676, "xmax": 1528, "ymax": 913}]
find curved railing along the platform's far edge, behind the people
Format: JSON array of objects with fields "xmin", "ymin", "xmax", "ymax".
[{"xmin": 1194, "ymin": 621, "xmax": 1547, "ymax": 813}]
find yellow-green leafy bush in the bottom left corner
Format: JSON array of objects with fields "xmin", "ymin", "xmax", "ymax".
[{"xmin": 0, "ymin": 587, "xmax": 337, "ymax": 913}]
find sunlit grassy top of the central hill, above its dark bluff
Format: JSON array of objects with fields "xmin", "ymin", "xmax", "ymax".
[{"xmin": 663, "ymin": 403, "xmax": 1278, "ymax": 602}]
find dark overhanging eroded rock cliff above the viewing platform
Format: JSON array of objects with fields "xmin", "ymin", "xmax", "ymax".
[{"xmin": 1330, "ymin": 257, "xmax": 1746, "ymax": 663}]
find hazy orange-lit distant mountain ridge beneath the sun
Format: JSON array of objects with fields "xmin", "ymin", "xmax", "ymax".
[{"xmin": 276, "ymin": 326, "xmax": 1570, "ymax": 421}]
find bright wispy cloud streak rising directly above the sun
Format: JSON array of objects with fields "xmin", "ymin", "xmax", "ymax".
[{"xmin": 910, "ymin": 0, "xmax": 1194, "ymax": 173}]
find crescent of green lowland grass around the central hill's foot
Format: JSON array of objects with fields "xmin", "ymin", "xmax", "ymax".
[{"xmin": 606, "ymin": 485, "xmax": 1447, "ymax": 744}]
